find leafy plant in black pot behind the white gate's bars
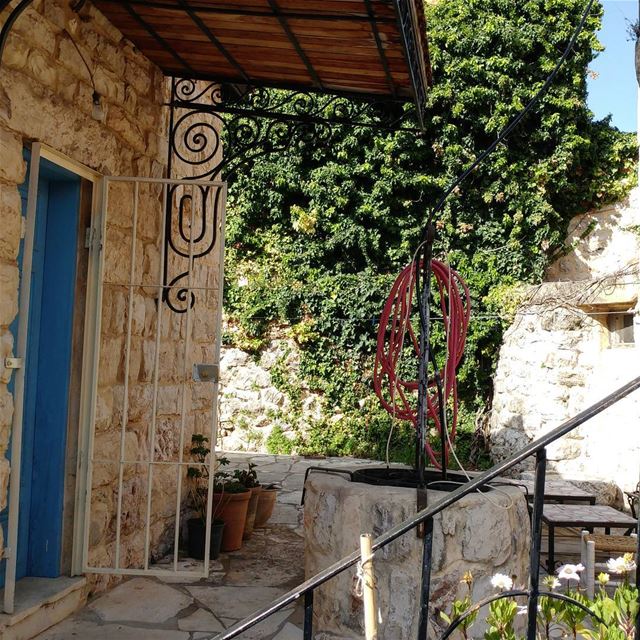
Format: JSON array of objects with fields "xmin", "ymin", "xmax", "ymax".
[{"xmin": 187, "ymin": 433, "xmax": 229, "ymax": 560}]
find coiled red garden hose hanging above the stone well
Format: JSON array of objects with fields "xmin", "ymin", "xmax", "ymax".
[{"xmin": 373, "ymin": 260, "xmax": 471, "ymax": 468}]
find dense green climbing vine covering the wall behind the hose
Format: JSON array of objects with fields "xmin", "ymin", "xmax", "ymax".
[{"xmin": 225, "ymin": 0, "xmax": 636, "ymax": 458}]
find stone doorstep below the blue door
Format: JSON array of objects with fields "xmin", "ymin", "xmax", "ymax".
[{"xmin": 0, "ymin": 576, "xmax": 88, "ymax": 640}]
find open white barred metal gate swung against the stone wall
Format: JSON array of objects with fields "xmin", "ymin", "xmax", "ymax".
[{"xmin": 83, "ymin": 177, "xmax": 226, "ymax": 577}]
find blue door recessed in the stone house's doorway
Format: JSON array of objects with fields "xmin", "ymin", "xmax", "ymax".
[{"xmin": 0, "ymin": 159, "xmax": 80, "ymax": 586}]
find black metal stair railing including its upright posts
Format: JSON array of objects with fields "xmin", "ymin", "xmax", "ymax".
[{"xmin": 214, "ymin": 376, "xmax": 640, "ymax": 640}]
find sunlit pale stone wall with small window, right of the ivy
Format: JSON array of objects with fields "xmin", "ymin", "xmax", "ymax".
[{"xmin": 490, "ymin": 188, "xmax": 640, "ymax": 498}]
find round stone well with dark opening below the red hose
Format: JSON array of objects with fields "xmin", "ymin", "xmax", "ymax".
[{"xmin": 304, "ymin": 473, "xmax": 530, "ymax": 640}]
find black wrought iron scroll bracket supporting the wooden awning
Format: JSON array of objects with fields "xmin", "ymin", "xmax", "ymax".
[{"xmin": 164, "ymin": 78, "xmax": 420, "ymax": 313}]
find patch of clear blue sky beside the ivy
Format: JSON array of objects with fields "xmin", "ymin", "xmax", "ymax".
[{"xmin": 588, "ymin": 0, "xmax": 638, "ymax": 131}]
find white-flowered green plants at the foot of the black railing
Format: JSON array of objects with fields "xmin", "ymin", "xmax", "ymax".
[{"xmin": 440, "ymin": 553, "xmax": 640, "ymax": 640}]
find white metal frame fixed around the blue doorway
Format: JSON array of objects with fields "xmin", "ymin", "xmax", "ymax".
[{"xmin": 3, "ymin": 142, "xmax": 101, "ymax": 614}]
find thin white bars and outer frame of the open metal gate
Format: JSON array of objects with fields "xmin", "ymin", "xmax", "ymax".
[{"xmin": 83, "ymin": 177, "xmax": 226, "ymax": 578}]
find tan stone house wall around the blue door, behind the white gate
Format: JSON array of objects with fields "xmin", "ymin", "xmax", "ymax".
[{"xmin": 0, "ymin": 0, "xmax": 220, "ymax": 584}]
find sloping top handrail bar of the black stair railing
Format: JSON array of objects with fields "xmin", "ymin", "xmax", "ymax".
[{"xmin": 213, "ymin": 376, "xmax": 640, "ymax": 640}]
